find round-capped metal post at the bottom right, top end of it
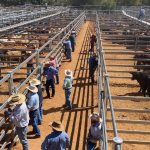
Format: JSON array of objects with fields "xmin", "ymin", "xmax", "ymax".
[{"xmin": 113, "ymin": 137, "xmax": 123, "ymax": 150}]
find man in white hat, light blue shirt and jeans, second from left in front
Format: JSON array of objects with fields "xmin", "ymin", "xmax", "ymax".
[{"xmin": 27, "ymin": 85, "xmax": 41, "ymax": 138}]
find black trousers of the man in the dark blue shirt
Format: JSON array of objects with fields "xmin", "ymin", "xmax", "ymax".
[{"xmin": 46, "ymin": 79, "xmax": 55, "ymax": 97}]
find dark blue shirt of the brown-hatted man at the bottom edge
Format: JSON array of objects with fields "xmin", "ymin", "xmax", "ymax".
[{"xmin": 41, "ymin": 131, "xmax": 70, "ymax": 150}]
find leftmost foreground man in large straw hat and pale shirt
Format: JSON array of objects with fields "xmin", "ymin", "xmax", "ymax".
[{"xmin": 5, "ymin": 93, "xmax": 29, "ymax": 150}]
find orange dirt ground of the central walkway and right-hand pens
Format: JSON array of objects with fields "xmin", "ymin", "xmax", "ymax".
[{"xmin": 1, "ymin": 19, "xmax": 150, "ymax": 150}]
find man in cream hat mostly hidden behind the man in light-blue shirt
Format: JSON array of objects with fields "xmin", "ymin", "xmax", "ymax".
[{"xmin": 29, "ymin": 78, "xmax": 43, "ymax": 124}]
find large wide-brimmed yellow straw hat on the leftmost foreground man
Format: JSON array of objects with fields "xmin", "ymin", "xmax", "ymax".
[{"xmin": 9, "ymin": 93, "xmax": 26, "ymax": 105}]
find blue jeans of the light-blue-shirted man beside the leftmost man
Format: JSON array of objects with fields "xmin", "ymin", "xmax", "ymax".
[{"xmin": 29, "ymin": 109, "xmax": 41, "ymax": 135}]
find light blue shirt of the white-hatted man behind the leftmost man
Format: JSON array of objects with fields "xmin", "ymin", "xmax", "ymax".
[{"xmin": 27, "ymin": 92, "xmax": 39, "ymax": 111}]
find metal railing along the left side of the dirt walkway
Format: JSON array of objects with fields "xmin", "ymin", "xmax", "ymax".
[{"xmin": 0, "ymin": 12, "xmax": 85, "ymax": 149}]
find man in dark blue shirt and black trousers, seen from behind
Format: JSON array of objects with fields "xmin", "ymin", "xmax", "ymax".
[{"xmin": 44, "ymin": 62, "xmax": 58, "ymax": 98}]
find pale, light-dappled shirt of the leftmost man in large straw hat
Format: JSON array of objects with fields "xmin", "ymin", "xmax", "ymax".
[{"xmin": 10, "ymin": 102, "xmax": 29, "ymax": 127}]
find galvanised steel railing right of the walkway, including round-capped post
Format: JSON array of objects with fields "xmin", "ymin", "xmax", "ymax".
[{"xmin": 96, "ymin": 12, "xmax": 123, "ymax": 150}]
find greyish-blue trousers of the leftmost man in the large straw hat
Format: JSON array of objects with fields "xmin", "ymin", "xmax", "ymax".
[{"xmin": 16, "ymin": 127, "xmax": 28, "ymax": 150}]
